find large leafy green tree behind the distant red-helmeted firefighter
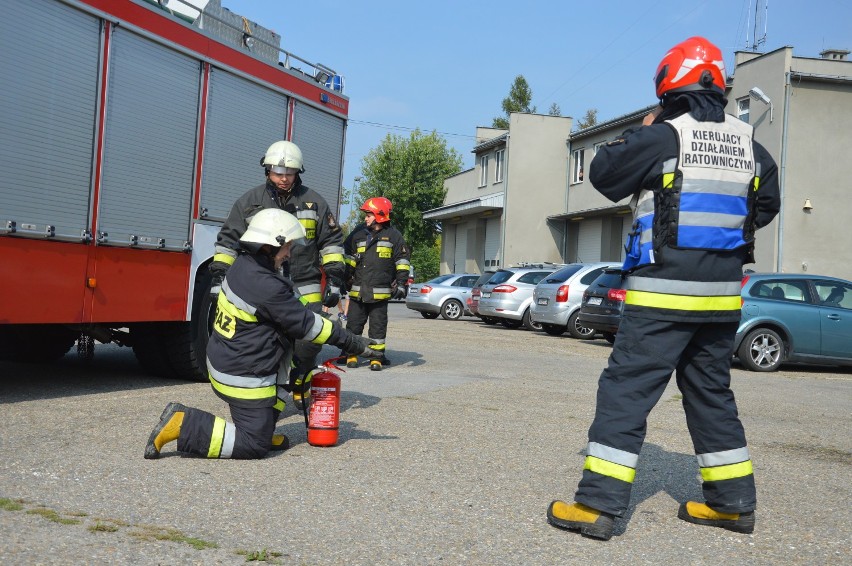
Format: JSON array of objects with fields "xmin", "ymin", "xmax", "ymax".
[{"xmin": 350, "ymin": 129, "xmax": 462, "ymax": 279}]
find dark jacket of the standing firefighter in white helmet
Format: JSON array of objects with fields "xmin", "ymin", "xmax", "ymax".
[{"xmin": 213, "ymin": 180, "xmax": 346, "ymax": 303}]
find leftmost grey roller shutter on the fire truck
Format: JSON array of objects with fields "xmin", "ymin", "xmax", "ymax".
[{"xmin": 0, "ymin": 0, "xmax": 100, "ymax": 242}]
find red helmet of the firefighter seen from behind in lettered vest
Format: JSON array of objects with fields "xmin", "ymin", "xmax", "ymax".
[{"xmin": 654, "ymin": 36, "xmax": 725, "ymax": 100}]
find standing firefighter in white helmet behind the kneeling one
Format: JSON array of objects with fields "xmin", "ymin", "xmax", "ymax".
[{"xmin": 210, "ymin": 141, "xmax": 346, "ymax": 408}]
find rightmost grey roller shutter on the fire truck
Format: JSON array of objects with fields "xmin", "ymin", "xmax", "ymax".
[{"xmin": 292, "ymin": 103, "xmax": 346, "ymax": 216}]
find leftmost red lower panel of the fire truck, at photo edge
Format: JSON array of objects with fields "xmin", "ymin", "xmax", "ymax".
[{"xmin": 0, "ymin": 242, "xmax": 90, "ymax": 324}]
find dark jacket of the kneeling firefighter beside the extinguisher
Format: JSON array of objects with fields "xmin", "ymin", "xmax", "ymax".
[{"xmin": 207, "ymin": 254, "xmax": 348, "ymax": 407}]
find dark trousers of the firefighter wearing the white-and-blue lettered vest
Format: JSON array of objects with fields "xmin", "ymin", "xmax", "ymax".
[{"xmin": 574, "ymin": 315, "xmax": 756, "ymax": 516}]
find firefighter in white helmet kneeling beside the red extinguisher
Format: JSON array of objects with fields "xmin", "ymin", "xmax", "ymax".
[{"xmin": 145, "ymin": 208, "xmax": 381, "ymax": 459}]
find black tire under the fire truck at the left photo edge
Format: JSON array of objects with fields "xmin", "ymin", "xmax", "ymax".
[{"xmin": 0, "ymin": 324, "xmax": 79, "ymax": 362}]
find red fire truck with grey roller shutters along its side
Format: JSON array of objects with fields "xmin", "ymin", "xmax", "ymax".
[{"xmin": 0, "ymin": 0, "xmax": 349, "ymax": 380}]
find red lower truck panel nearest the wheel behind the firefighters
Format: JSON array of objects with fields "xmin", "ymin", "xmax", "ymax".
[{"xmin": 85, "ymin": 246, "xmax": 190, "ymax": 323}]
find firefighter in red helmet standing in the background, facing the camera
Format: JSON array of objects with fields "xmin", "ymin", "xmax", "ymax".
[{"xmin": 343, "ymin": 197, "xmax": 411, "ymax": 371}]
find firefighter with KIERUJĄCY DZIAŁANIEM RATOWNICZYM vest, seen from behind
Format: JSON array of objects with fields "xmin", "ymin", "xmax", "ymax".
[{"xmin": 547, "ymin": 37, "xmax": 780, "ymax": 540}]
